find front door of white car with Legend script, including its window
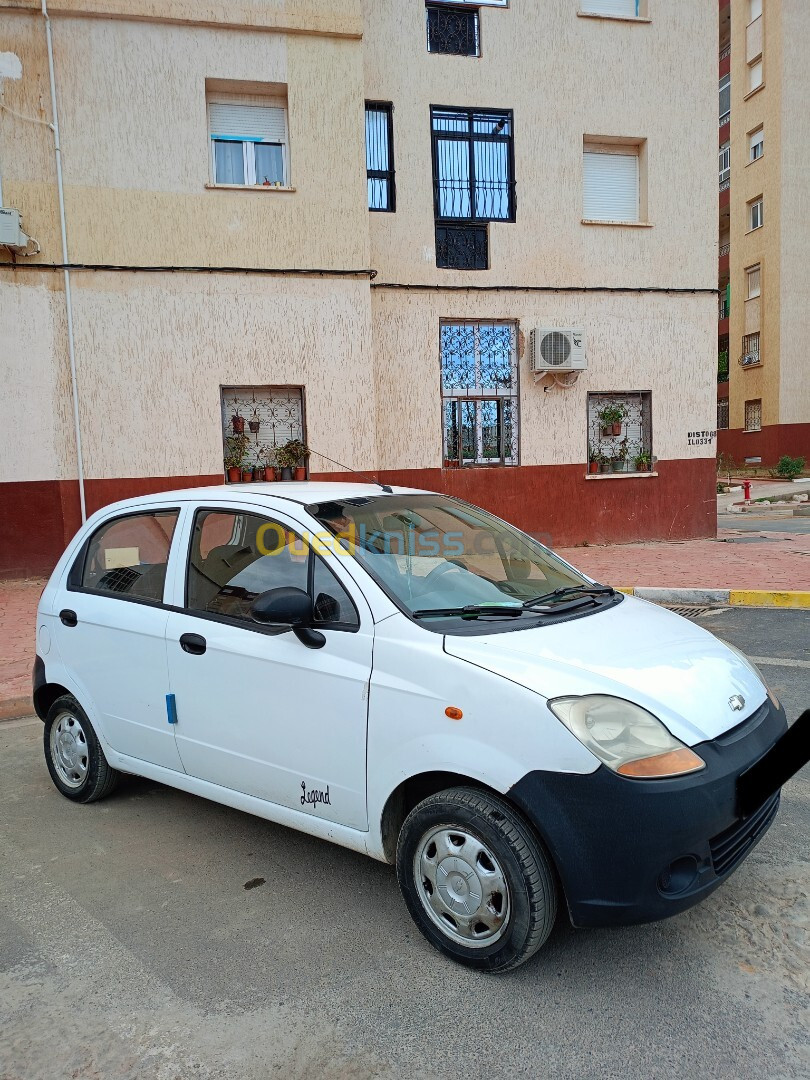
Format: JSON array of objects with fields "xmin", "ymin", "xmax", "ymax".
[{"xmin": 166, "ymin": 508, "xmax": 373, "ymax": 829}]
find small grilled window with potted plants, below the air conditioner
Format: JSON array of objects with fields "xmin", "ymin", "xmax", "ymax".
[{"xmin": 588, "ymin": 390, "xmax": 653, "ymax": 473}]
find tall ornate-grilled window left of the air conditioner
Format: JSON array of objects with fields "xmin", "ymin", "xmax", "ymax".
[{"xmin": 440, "ymin": 323, "xmax": 519, "ymax": 467}]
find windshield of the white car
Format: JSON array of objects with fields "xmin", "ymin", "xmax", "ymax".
[{"xmin": 307, "ymin": 495, "xmax": 591, "ymax": 618}]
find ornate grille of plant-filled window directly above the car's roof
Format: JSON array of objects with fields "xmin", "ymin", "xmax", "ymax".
[{"xmin": 221, "ymin": 387, "xmax": 303, "ymax": 468}]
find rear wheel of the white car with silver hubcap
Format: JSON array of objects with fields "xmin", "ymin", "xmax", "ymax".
[{"xmin": 43, "ymin": 693, "xmax": 121, "ymax": 802}]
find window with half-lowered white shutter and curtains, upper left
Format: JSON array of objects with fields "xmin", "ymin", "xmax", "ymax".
[{"xmin": 208, "ymin": 99, "xmax": 289, "ymax": 187}]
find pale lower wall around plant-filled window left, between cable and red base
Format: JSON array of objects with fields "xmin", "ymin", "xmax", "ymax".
[{"xmin": 0, "ymin": 272, "xmax": 375, "ymax": 482}]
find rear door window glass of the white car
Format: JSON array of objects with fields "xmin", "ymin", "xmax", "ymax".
[{"xmin": 81, "ymin": 510, "xmax": 178, "ymax": 603}]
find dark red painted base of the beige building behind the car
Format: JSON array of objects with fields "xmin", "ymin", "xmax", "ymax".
[{"xmin": 0, "ymin": 458, "xmax": 717, "ymax": 578}]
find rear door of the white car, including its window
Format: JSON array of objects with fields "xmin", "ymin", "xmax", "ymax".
[{"xmin": 54, "ymin": 507, "xmax": 183, "ymax": 772}]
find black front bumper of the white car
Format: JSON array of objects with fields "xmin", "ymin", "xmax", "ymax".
[{"xmin": 509, "ymin": 698, "xmax": 787, "ymax": 927}]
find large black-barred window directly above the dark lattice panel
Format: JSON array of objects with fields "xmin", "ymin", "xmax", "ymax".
[{"xmin": 431, "ymin": 106, "xmax": 515, "ymax": 221}]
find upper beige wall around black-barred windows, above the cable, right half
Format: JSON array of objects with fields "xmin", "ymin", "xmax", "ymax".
[{"xmin": 363, "ymin": 0, "xmax": 717, "ymax": 288}]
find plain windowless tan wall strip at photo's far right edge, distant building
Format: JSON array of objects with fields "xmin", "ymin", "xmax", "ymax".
[{"xmin": 780, "ymin": 0, "xmax": 810, "ymax": 423}]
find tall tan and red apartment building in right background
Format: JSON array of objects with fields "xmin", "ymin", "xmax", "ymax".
[{"xmin": 717, "ymin": 0, "xmax": 810, "ymax": 468}]
